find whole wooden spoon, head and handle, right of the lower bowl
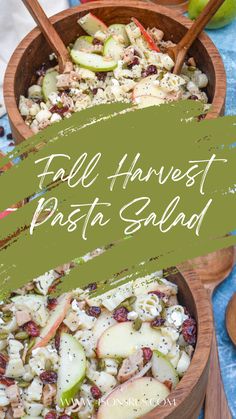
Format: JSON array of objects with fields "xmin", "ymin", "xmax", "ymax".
[{"xmin": 182, "ymin": 247, "xmax": 234, "ymax": 419}]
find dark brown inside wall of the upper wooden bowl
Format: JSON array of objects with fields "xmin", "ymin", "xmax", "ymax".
[{"xmin": 15, "ymin": 3, "xmax": 215, "ymax": 102}]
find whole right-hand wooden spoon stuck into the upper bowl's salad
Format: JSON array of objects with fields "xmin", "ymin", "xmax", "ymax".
[{"xmin": 167, "ymin": 0, "xmax": 225, "ymax": 74}]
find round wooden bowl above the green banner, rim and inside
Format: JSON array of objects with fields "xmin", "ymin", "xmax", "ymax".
[{"xmin": 4, "ymin": 0, "xmax": 226, "ymax": 142}]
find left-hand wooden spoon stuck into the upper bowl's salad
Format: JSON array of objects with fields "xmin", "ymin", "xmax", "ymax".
[{"xmin": 22, "ymin": 0, "xmax": 71, "ymax": 73}]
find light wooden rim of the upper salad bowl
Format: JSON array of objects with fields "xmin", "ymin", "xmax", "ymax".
[{"xmin": 4, "ymin": 0, "xmax": 226, "ymax": 141}]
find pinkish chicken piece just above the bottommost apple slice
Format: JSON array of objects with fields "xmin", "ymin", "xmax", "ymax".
[{"xmin": 117, "ymin": 349, "xmax": 144, "ymax": 383}]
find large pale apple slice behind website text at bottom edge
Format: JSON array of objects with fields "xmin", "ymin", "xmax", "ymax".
[{"xmin": 97, "ymin": 377, "xmax": 170, "ymax": 419}]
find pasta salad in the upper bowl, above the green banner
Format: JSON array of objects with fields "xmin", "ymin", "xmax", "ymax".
[{"xmin": 19, "ymin": 13, "xmax": 208, "ymax": 133}]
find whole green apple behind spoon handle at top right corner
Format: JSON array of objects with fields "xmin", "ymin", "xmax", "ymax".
[{"xmin": 188, "ymin": 0, "xmax": 236, "ymax": 29}]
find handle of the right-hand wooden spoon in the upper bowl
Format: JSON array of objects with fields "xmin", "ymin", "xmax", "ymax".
[{"xmin": 178, "ymin": 0, "xmax": 225, "ymax": 50}]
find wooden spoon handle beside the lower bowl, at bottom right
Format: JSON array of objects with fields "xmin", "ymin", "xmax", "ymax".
[{"xmin": 204, "ymin": 330, "xmax": 232, "ymax": 419}]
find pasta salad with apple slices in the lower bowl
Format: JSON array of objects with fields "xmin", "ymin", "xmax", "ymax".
[{"xmin": 0, "ymin": 265, "xmax": 196, "ymax": 419}]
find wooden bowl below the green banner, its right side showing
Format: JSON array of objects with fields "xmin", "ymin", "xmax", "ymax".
[{"xmin": 148, "ymin": 268, "xmax": 213, "ymax": 419}]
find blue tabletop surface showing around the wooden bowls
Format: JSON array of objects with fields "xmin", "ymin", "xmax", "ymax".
[{"xmin": 0, "ymin": 0, "xmax": 236, "ymax": 419}]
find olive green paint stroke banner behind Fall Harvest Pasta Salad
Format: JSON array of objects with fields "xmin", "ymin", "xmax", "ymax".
[{"xmin": 0, "ymin": 101, "xmax": 236, "ymax": 295}]
